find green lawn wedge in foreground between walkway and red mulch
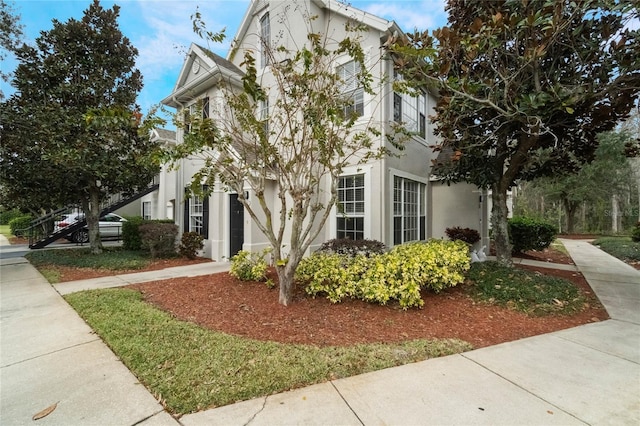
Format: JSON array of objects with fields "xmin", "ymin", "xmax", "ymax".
[{"xmin": 66, "ymin": 289, "xmax": 472, "ymax": 414}]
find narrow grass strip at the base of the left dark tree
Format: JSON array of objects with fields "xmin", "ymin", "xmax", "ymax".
[{"xmin": 25, "ymin": 247, "xmax": 151, "ymax": 271}]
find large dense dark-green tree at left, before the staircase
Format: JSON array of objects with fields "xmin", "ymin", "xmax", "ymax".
[{"xmin": 0, "ymin": 0, "xmax": 159, "ymax": 253}]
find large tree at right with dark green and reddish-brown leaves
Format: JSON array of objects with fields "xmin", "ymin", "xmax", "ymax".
[{"xmin": 391, "ymin": 0, "xmax": 640, "ymax": 264}]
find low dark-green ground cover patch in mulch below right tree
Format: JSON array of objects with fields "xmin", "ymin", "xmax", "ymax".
[{"xmin": 468, "ymin": 261, "xmax": 586, "ymax": 315}]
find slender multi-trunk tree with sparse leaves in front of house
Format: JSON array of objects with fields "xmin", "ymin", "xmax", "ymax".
[{"xmin": 170, "ymin": 11, "xmax": 396, "ymax": 305}]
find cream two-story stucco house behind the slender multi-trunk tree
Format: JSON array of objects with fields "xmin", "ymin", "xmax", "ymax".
[{"xmin": 158, "ymin": 0, "xmax": 488, "ymax": 260}]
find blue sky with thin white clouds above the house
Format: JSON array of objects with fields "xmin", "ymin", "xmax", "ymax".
[{"xmin": 2, "ymin": 0, "xmax": 446, "ymax": 113}]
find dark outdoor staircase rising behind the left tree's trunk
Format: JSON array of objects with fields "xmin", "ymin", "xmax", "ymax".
[{"xmin": 21, "ymin": 182, "xmax": 160, "ymax": 249}]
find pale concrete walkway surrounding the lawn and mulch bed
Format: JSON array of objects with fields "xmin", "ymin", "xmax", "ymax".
[{"xmin": 0, "ymin": 238, "xmax": 640, "ymax": 425}]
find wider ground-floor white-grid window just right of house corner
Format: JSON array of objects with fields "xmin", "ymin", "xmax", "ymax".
[{"xmin": 393, "ymin": 176, "xmax": 427, "ymax": 244}]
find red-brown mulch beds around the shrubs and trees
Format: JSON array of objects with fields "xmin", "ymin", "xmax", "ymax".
[{"xmin": 46, "ymin": 246, "xmax": 608, "ymax": 347}]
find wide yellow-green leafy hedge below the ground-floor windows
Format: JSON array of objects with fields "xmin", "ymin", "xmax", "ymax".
[{"xmin": 296, "ymin": 240, "xmax": 469, "ymax": 309}]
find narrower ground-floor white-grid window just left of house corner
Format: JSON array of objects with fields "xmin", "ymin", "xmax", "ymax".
[{"xmin": 336, "ymin": 174, "xmax": 365, "ymax": 240}]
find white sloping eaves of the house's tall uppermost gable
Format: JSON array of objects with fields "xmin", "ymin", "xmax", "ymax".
[{"xmin": 227, "ymin": 0, "xmax": 402, "ymax": 59}]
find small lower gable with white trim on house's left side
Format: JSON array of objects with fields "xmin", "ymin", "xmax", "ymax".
[{"xmin": 161, "ymin": 43, "xmax": 244, "ymax": 108}]
